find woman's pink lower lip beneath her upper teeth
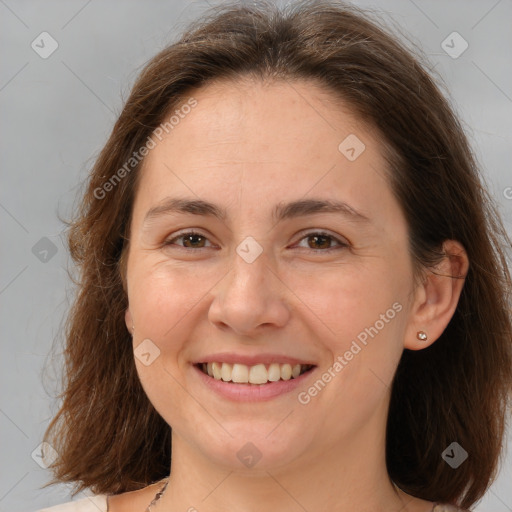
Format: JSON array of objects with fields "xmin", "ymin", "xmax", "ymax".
[{"xmin": 192, "ymin": 365, "xmax": 316, "ymax": 402}]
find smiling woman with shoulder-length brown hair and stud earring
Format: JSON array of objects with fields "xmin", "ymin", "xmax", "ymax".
[{"xmin": 37, "ymin": 1, "xmax": 512, "ymax": 512}]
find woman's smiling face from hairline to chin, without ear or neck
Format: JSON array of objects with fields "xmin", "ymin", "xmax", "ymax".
[{"xmin": 126, "ymin": 82, "xmax": 420, "ymax": 469}]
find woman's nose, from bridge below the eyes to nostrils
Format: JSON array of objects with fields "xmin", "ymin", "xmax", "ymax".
[{"xmin": 208, "ymin": 247, "xmax": 290, "ymax": 337}]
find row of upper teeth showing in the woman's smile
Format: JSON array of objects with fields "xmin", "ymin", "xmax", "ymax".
[{"xmin": 200, "ymin": 362, "xmax": 311, "ymax": 384}]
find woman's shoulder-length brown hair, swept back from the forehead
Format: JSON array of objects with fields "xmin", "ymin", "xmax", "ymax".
[{"xmin": 45, "ymin": 0, "xmax": 512, "ymax": 507}]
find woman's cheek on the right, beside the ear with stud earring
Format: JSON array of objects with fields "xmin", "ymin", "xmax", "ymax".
[{"xmin": 288, "ymin": 264, "xmax": 407, "ymax": 400}]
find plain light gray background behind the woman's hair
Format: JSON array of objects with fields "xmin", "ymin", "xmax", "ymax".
[{"xmin": 0, "ymin": 0, "xmax": 512, "ymax": 512}]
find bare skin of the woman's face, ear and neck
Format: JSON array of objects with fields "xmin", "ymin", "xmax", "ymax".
[{"xmin": 109, "ymin": 81, "xmax": 468, "ymax": 512}]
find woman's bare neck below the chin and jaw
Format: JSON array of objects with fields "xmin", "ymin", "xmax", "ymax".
[{"xmin": 155, "ymin": 420, "xmax": 430, "ymax": 512}]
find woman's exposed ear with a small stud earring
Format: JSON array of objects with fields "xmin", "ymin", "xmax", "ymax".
[{"xmin": 404, "ymin": 240, "xmax": 469, "ymax": 350}]
